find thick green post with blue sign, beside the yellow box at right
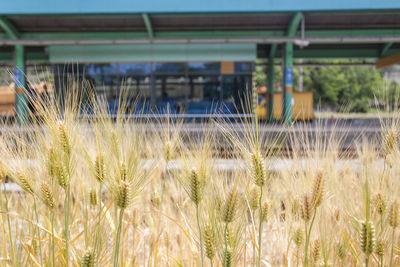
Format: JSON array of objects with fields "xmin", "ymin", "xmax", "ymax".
[{"xmin": 283, "ymin": 43, "xmax": 293, "ymax": 124}]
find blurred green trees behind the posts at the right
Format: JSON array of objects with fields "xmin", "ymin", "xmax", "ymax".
[{"xmin": 256, "ymin": 62, "xmax": 400, "ymax": 112}]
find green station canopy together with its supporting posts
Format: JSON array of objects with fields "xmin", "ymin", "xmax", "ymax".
[{"xmin": 0, "ymin": 0, "xmax": 400, "ymax": 123}]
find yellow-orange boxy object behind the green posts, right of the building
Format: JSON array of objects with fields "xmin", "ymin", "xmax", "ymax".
[{"xmin": 256, "ymin": 92, "xmax": 314, "ymax": 121}]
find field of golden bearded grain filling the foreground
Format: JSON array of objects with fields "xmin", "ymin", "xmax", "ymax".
[{"xmin": 0, "ymin": 90, "xmax": 400, "ymax": 267}]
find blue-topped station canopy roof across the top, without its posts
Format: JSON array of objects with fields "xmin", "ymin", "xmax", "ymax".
[{"xmin": 0, "ymin": 0, "xmax": 400, "ymax": 65}]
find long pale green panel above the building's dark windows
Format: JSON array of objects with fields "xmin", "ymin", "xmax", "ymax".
[{"xmin": 49, "ymin": 43, "xmax": 257, "ymax": 63}]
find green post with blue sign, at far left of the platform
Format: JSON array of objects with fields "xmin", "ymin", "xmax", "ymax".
[{"xmin": 14, "ymin": 45, "xmax": 28, "ymax": 124}]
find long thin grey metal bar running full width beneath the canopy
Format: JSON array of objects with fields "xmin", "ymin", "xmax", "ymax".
[{"xmin": 0, "ymin": 35, "xmax": 400, "ymax": 46}]
